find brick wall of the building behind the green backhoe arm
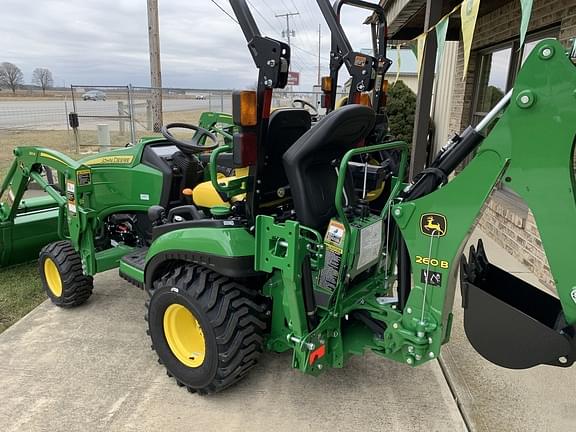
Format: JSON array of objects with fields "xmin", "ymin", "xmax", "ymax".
[{"xmin": 450, "ymin": 0, "xmax": 576, "ymax": 287}]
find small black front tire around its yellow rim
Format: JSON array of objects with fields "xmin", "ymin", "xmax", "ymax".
[{"xmin": 38, "ymin": 240, "xmax": 94, "ymax": 308}]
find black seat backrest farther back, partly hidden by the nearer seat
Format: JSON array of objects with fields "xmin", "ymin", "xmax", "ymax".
[{"xmin": 258, "ymin": 109, "xmax": 312, "ymax": 203}]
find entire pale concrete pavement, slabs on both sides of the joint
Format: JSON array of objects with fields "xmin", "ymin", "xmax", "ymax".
[{"xmin": 0, "ymin": 228, "xmax": 576, "ymax": 432}]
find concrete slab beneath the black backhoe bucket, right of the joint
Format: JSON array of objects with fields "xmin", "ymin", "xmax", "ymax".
[{"xmin": 441, "ymin": 230, "xmax": 576, "ymax": 432}]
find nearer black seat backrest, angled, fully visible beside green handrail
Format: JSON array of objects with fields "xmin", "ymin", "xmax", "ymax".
[{"xmin": 283, "ymin": 105, "xmax": 375, "ymax": 229}]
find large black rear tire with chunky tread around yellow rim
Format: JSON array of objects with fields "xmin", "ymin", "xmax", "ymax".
[{"xmin": 146, "ymin": 264, "xmax": 268, "ymax": 395}]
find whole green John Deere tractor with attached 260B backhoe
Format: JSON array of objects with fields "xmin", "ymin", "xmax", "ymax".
[{"xmin": 0, "ymin": 0, "xmax": 576, "ymax": 394}]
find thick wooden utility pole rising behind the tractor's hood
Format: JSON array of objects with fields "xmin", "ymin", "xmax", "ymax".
[{"xmin": 147, "ymin": 0, "xmax": 162, "ymax": 132}]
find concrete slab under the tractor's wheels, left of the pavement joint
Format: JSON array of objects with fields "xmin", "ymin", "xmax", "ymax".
[{"xmin": 0, "ymin": 271, "xmax": 466, "ymax": 432}]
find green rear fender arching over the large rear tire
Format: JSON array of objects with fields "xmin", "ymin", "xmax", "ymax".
[{"xmin": 144, "ymin": 227, "xmax": 259, "ymax": 287}]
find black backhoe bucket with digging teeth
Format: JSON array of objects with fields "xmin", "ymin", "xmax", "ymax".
[{"xmin": 460, "ymin": 240, "xmax": 576, "ymax": 369}]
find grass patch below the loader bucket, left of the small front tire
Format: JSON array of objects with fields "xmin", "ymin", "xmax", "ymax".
[{"xmin": 0, "ymin": 263, "xmax": 46, "ymax": 333}]
